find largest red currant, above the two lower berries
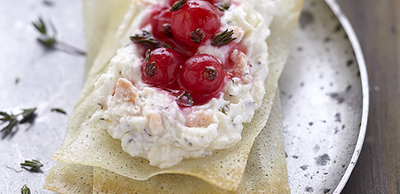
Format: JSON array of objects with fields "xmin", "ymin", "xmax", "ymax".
[{"xmin": 171, "ymin": 0, "xmax": 221, "ymax": 49}]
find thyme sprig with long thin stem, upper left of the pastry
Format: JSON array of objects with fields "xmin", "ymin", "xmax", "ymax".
[{"xmin": 32, "ymin": 16, "xmax": 86, "ymax": 55}]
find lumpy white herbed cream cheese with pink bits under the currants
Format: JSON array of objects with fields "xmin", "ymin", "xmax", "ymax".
[{"xmin": 91, "ymin": 0, "xmax": 278, "ymax": 168}]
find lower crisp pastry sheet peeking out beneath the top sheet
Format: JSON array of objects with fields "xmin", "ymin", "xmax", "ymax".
[{"xmin": 45, "ymin": 90, "xmax": 289, "ymax": 194}]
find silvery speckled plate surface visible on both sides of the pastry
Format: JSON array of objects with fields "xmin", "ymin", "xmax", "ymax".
[{"xmin": 0, "ymin": 0, "xmax": 363, "ymax": 193}]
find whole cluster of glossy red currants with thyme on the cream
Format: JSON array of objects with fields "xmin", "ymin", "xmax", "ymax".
[{"xmin": 131, "ymin": 0, "xmax": 242, "ymax": 106}]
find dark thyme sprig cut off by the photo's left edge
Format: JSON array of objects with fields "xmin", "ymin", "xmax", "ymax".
[{"xmin": 0, "ymin": 108, "xmax": 36, "ymax": 133}]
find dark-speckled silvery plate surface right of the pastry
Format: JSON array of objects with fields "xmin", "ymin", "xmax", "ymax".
[{"xmin": 280, "ymin": 0, "xmax": 368, "ymax": 193}]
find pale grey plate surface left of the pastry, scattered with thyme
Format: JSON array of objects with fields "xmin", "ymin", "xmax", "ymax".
[{"xmin": 0, "ymin": 0, "xmax": 85, "ymax": 194}]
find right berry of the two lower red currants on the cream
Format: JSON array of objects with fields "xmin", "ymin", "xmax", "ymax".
[{"xmin": 179, "ymin": 54, "xmax": 226, "ymax": 94}]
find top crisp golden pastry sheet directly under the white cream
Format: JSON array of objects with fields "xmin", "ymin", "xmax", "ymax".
[{"xmin": 47, "ymin": 0, "xmax": 302, "ymax": 191}]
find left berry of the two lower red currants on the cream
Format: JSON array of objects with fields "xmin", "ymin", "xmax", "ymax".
[{"xmin": 141, "ymin": 48, "xmax": 184, "ymax": 88}]
